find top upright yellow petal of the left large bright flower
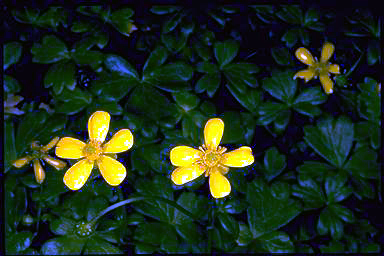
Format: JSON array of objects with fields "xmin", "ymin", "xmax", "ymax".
[{"xmin": 88, "ymin": 111, "xmax": 111, "ymax": 142}]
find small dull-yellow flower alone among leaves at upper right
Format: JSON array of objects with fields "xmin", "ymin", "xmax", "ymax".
[{"xmin": 293, "ymin": 42, "xmax": 340, "ymax": 94}]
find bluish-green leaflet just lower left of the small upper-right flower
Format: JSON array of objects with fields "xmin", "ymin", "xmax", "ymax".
[{"xmin": 263, "ymin": 71, "xmax": 297, "ymax": 105}]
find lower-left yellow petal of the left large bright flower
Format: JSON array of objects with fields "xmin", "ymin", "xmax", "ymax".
[{"xmin": 63, "ymin": 159, "xmax": 94, "ymax": 190}]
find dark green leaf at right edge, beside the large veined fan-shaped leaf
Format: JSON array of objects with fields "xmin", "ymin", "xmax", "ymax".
[{"xmin": 344, "ymin": 147, "xmax": 380, "ymax": 179}]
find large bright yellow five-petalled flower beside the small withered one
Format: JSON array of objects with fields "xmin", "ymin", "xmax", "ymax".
[{"xmin": 56, "ymin": 111, "xmax": 133, "ymax": 190}]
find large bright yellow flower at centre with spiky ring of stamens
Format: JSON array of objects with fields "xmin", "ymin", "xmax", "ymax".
[{"xmin": 170, "ymin": 118, "xmax": 254, "ymax": 198}]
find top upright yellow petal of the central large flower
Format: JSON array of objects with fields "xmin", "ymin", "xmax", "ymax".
[{"xmin": 204, "ymin": 118, "xmax": 224, "ymax": 150}]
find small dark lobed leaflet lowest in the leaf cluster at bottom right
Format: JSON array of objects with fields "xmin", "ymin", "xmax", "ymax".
[{"xmin": 317, "ymin": 207, "xmax": 344, "ymax": 240}]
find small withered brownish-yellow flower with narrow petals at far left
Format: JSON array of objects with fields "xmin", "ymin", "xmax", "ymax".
[{"xmin": 12, "ymin": 137, "xmax": 67, "ymax": 184}]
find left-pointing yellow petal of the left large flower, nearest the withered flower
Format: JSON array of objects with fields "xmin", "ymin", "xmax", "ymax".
[{"xmin": 56, "ymin": 137, "xmax": 86, "ymax": 159}]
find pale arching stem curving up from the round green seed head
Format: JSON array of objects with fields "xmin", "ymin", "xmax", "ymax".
[{"xmin": 90, "ymin": 196, "xmax": 201, "ymax": 225}]
